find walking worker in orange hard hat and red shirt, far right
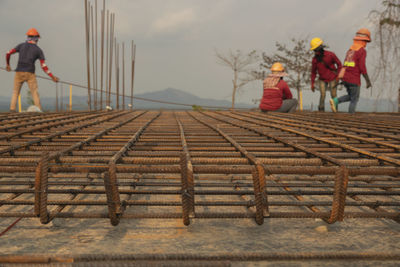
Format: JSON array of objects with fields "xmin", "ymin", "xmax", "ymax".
[{"xmin": 330, "ymin": 28, "xmax": 372, "ymax": 113}]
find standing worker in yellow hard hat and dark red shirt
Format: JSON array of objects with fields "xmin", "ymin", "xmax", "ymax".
[{"xmin": 310, "ymin": 37, "xmax": 342, "ymax": 111}]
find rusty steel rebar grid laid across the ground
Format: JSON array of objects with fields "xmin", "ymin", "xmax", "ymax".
[{"xmin": 0, "ymin": 110, "xmax": 400, "ymax": 225}]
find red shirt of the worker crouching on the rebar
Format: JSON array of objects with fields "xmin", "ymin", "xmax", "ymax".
[{"xmin": 259, "ymin": 78, "xmax": 293, "ymax": 110}]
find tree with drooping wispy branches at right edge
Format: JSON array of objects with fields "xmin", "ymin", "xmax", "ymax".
[{"xmin": 370, "ymin": 0, "xmax": 400, "ymax": 112}]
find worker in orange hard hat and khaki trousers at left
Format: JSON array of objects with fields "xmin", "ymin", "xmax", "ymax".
[{"xmin": 6, "ymin": 28, "xmax": 59, "ymax": 112}]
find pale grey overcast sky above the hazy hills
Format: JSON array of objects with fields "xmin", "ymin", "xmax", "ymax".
[{"xmin": 0, "ymin": 0, "xmax": 381, "ymax": 108}]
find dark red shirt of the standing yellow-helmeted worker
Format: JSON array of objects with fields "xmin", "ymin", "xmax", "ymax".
[{"xmin": 311, "ymin": 51, "xmax": 342, "ymax": 85}]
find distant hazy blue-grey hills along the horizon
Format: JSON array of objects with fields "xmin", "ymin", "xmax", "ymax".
[{"xmin": 0, "ymin": 88, "xmax": 396, "ymax": 112}]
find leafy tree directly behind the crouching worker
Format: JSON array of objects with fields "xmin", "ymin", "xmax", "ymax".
[{"xmin": 254, "ymin": 38, "xmax": 313, "ymax": 101}]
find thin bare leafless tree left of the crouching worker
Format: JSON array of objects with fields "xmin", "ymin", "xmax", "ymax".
[{"xmin": 215, "ymin": 50, "xmax": 259, "ymax": 109}]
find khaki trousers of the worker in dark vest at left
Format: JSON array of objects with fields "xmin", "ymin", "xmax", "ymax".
[{"xmin": 10, "ymin": 71, "xmax": 42, "ymax": 111}]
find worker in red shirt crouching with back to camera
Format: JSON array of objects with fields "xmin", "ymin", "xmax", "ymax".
[{"xmin": 259, "ymin": 62, "xmax": 297, "ymax": 112}]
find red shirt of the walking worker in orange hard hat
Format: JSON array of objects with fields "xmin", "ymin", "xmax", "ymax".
[{"xmin": 342, "ymin": 47, "xmax": 367, "ymax": 86}]
